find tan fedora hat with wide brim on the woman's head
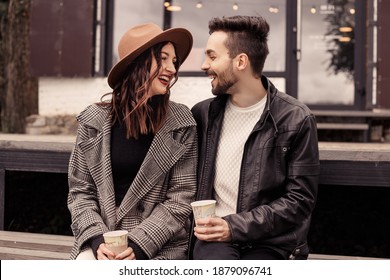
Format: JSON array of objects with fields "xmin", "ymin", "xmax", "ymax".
[{"xmin": 107, "ymin": 23, "xmax": 193, "ymax": 89}]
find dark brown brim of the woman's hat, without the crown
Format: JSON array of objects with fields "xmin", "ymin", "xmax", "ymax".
[{"xmin": 107, "ymin": 28, "xmax": 193, "ymax": 89}]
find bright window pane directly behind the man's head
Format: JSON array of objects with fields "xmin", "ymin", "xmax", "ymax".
[{"xmin": 171, "ymin": 0, "xmax": 286, "ymax": 71}]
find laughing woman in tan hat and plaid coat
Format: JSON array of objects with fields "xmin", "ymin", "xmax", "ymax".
[{"xmin": 68, "ymin": 24, "xmax": 197, "ymax": 260}]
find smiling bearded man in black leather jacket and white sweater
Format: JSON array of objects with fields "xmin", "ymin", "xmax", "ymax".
[{"xmin": 190, "ymin": 16, "xmax": 319, "ymax": 260}]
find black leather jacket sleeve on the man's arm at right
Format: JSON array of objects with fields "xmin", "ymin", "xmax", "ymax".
[{"xmin": 224, "ymin": 115, "xmax": 320, "ymax": 242}]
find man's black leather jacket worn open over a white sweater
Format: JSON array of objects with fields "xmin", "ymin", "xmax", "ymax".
[{"xmin": 192, "ymin": 76, "xmax": 320, "ymax": 256}]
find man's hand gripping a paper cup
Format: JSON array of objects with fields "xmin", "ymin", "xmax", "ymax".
[{"xmin": 194, "ymin": 217, "xmax": 232, "ymax": 242}]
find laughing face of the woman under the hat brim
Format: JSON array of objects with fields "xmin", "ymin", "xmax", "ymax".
[{"xmin": 149, "ymin": 43, "xmax": 176, "ymax": 96}]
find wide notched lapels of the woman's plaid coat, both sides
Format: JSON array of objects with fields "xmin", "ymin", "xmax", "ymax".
[{"xmin": 75, "ymin": 103, "xmax": 195, "ymax": 230}]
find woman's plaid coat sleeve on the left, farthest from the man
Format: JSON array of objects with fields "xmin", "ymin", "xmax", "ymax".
[{"xmin": 67, "ymin": 124, "xmax": 108, "ymax": 250}]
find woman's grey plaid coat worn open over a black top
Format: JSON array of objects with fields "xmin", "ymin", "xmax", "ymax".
[{"xmin": 68, "ymin": 101, "xmax": 197, "ymax": 259}]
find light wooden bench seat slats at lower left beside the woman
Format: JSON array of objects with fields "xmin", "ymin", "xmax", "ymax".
[{"xmin": 0, "ymin": 231, "xmax": 74, "ymax": 260}]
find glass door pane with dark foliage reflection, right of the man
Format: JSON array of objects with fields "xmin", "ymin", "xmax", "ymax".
[{"xmin": 296, "ymin": 0, "xmax": 364, "ymax": 108}]
